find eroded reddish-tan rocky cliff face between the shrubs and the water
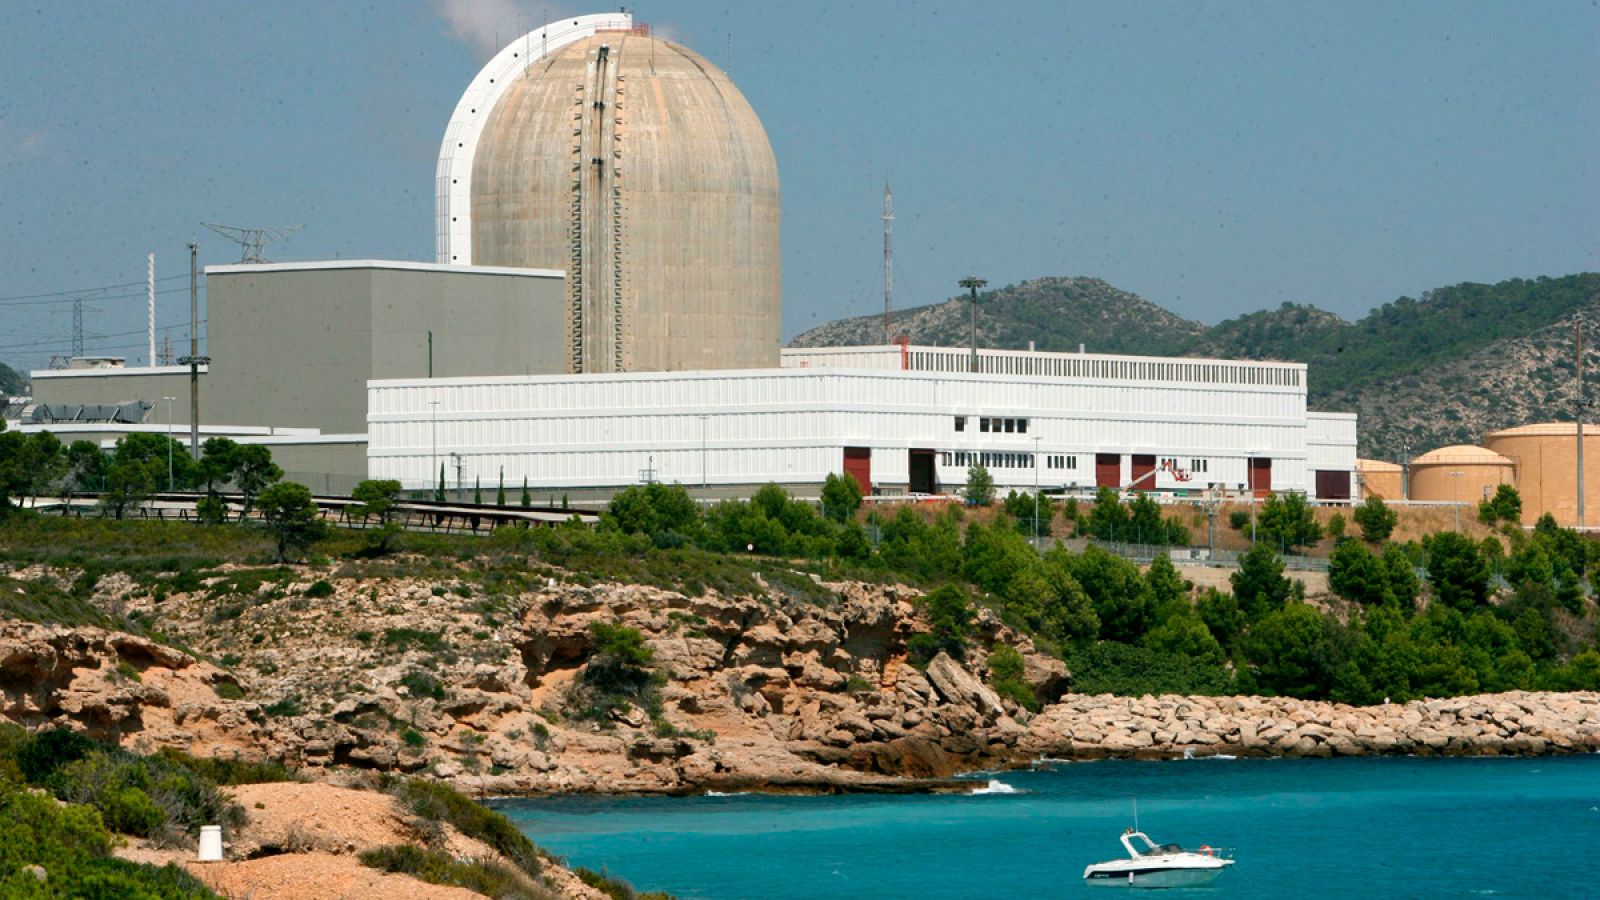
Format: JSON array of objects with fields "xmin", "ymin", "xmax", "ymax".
[{"xmin": 0, "ymin": 570, "xmax": 1067, "ymax": 793}]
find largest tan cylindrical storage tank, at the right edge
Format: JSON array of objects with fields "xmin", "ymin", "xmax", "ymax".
[{"xmin": 1483, "ymin": 421, "xmax": 1600, "ymax": 527}]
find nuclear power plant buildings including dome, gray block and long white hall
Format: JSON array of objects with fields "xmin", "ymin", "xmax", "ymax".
[{"xmin": 9, "ymin": 13, "xmax": 1360, "ymax": 503}]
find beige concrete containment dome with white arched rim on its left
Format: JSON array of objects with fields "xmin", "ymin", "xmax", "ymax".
[{"xmin": 438, "ymin": 14, "xmax": 779, "ymax": 372}]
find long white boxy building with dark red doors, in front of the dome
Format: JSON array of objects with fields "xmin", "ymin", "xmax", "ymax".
[{"xmin": 368, "ymin": 346, "xmax": 1355, "ymax": 501}]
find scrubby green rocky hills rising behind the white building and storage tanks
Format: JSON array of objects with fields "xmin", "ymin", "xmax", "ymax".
[{"xmin": 792, "ymin": 272, "xmax": 1600, "ymax": 460}]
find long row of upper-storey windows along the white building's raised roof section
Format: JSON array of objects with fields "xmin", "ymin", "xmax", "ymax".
[{"xmin": 907, "ymin": 351, "xmax": 1301, "ymax": 388}]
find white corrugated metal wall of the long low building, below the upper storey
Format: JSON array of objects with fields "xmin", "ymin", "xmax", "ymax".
[{"xmin": 368, "ymin": 368, "xmax": 1355, "ymax": 490}]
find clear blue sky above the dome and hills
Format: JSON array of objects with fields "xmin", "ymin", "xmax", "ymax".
[{"xmin": 0, "ymin": 0, "xmax": 1600, "ymax": 368}]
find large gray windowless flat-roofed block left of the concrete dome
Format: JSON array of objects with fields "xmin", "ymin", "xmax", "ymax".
[{"xmin": 209, "ymin": 259, "xmax": 565, "ymax": 434}]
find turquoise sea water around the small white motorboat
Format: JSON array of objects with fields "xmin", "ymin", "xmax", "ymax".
[{"xmin": 499, "ymin": 756, "xmax": 1600, "ymax": 900}]
